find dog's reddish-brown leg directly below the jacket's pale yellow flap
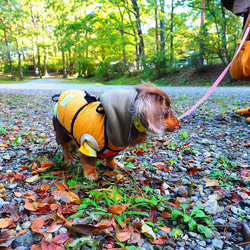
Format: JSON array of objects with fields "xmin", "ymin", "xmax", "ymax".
[{"xmin": 80, "ymin": 154, "xmax": 98, "ymax": 181}]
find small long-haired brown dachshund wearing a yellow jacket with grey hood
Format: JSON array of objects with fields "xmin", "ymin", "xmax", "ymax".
[{"xmin": 53, "ymin": 83, "xmax": 180, "ymax": 180}]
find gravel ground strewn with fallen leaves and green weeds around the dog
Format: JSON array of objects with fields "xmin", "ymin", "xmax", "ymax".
[{"xmin": 0, "ymin": 91, "xmax": 250, "ymax": 250}]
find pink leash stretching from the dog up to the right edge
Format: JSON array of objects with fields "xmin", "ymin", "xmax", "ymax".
[{"xmin": 178, "ymin": 23, "xmax": 250, "ymax": 120}]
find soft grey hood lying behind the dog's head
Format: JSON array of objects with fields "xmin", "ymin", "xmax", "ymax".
[{"xmin": 100, "ymin": 89, "xmax": 137, "ymax": 147}]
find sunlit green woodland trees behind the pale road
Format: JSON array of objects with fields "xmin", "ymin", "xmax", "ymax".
[{"xmin": 0, "ymin": 0, "xmax": 242, "ymax": 85}]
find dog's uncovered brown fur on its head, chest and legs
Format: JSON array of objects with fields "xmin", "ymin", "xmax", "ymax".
[{"xmin": 59, "ymin": 83, "xmax": 180, "ymax": 180}]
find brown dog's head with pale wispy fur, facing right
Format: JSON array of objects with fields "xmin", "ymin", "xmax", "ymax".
[{"xmin": 134, "ymin": 82, "xmax": 180, "ymax": 134}]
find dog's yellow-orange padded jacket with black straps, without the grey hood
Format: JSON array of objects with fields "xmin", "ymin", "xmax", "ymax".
[{"xmin": 55, "ymin": 90, "xmax": 134, "ymax": 158}]
